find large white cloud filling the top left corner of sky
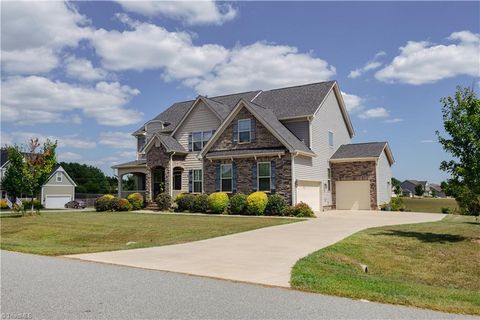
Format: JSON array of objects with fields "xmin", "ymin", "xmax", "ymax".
[{"xmin": 1, "ymin": 1, "xmax": 91, "ymax": 74}]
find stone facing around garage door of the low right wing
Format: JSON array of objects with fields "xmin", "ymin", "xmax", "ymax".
[{"xmin": 330, "ymin": 161, "xmax": 378, "ymax": 210}]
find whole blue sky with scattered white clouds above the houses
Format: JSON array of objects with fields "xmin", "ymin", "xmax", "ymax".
[{"xmin": 1, "ymin": 1, "xmax": 480, "ymax": 182}]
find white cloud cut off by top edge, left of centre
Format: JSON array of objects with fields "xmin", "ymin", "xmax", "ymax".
[{"xmin": 117, "ymin": 0, "xmax": 237, "ymax": 25}]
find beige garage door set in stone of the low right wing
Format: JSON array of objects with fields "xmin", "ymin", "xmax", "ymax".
[{"xmin": 335, "ymin": 180, "xmax": 370, "ymax": 210}]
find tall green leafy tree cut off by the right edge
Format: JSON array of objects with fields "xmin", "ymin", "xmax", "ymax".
[{"xmin": 436, "ymin": 87, "xmax": 480, "ymax": 216}]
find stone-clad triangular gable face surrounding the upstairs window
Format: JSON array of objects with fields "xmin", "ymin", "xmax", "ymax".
[{"xmin": 210, "ymin": 108, "xmax": 284, "ymax": 151}]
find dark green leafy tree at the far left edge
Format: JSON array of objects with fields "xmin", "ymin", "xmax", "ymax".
[{"xmin": 2, "ymin": 145, "xmax": 27, "ymax": 201}]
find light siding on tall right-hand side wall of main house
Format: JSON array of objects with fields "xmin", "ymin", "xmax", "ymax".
[{"xmin": 294, "ymin": 90, "xmax": 351, "ymax": 206}]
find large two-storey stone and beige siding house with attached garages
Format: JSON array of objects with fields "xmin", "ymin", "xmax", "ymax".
[{"xmin": 112, "ymin": 81, "xmax": 394, "ymax": 211}]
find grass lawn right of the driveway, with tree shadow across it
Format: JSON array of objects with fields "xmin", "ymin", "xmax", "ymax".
[{"xmin": 291, "ymin": 215, "xmax": 480, "ymax": 315}]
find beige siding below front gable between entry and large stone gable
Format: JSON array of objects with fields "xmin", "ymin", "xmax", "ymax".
[{"xmin": 174, "ymin": 101, "xmax": 220, "ymax": 192}]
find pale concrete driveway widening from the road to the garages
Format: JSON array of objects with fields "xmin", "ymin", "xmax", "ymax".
[{"xmin": 67, "ymin": 210, "xmax": 444, "ymax": 287}]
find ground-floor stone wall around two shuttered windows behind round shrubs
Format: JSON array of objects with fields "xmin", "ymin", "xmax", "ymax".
[{"xmin": 203, "ymin": 153, "xmax": 292, "ymax": 204}]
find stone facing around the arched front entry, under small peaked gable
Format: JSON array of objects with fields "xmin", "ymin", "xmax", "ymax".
[{"xmin": 145, "ymin": 145, "xmax": 170, "ymax": 201}]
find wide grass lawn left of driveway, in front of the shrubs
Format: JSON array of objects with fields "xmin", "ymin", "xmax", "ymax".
[{"xmin": 0, "ymin": 212, "xmax": 300, "ymax": 255}]
